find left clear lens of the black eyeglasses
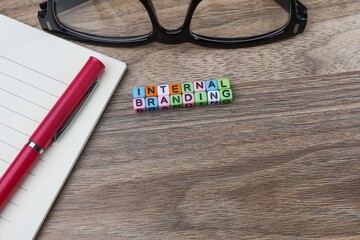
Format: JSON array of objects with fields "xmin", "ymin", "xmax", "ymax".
[{"xmin": 54, "ymin": 0, "xmax": 152, "ymax": 37}]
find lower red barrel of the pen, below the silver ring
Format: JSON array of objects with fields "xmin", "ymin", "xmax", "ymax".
[{"xmin": 0, "ymin": 145, "xmax": 40, "ymax": 210}]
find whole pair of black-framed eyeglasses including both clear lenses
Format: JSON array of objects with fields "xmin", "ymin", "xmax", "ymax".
[{"xmin": 38, "ymin": 0, "xmax": 307, "ymax": 48}]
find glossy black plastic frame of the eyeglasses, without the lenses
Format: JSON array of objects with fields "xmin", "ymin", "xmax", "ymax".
[{"xmin": 38, "ymin": 0, "xmax": 307, "ymax": 48}]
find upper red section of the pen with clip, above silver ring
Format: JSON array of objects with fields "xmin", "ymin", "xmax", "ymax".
[{"xmin": 30, "ymin": 57, "xmax": 105, "ymax": 150}]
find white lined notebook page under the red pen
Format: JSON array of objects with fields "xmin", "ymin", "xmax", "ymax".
[{"xmin": 0, "ymin": 15, "xmax": 126, "ymax": 240}]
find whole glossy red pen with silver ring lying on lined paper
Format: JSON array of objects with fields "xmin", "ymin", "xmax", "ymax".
[{"xmin": 0, "ymin": 57, "xmax": 105, "ymax": 210}]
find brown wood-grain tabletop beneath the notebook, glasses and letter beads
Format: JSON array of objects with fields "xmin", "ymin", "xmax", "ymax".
[{"xmin": 0, "ymin": 0, "xmax": 360, "ymax": 240}]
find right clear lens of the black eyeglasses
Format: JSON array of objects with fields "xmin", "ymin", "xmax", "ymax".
[{"xmin": 190, "ymin": 0, "xmax": 289, "ymax": 38}]
